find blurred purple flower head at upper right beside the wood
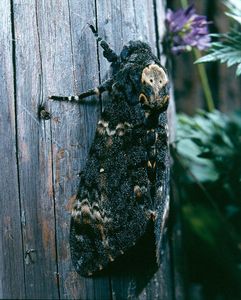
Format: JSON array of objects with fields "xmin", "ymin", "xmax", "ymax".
[{"xmin": 166, "ymin": 5, "xmax": 211, "ymax": 54}]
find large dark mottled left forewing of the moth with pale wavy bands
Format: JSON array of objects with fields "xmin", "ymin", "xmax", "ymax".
[{"xmin": 70, "ymin": 108, "xmax": 153, "ymax": 276}]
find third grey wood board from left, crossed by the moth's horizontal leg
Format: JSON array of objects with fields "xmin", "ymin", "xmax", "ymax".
[{"xmin": 35, "ymin": 1, "xmax": 86, "ymax": 299}]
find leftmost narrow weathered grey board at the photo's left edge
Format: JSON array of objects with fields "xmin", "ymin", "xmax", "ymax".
[{"xmin": 0, "ymin": 0, "xmax": 25, "ymax": 298}]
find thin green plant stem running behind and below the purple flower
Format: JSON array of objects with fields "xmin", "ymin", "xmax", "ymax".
[{"xmin": 180, "ymin": 0, "xmax": 215, "ymax": 112}]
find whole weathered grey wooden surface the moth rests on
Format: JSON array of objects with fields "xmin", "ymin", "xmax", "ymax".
[{"xmin": 0, "ymin": 0, "xmax": 177, "ymax": 299}]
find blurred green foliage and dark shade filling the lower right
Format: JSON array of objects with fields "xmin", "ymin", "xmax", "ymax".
[{"xmin": 173, "ymin": 111, "xmax": 241, "ymax": 299}]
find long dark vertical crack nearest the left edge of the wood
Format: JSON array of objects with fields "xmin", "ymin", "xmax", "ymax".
[{"xmin": 10, "ymin": 0, "xmax": 27, "ymax": 296}]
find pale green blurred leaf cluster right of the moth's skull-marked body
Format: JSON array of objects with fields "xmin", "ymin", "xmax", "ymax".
[{"xmin": 176, "ymin": 111, "xmax": 241, "ymax": 182}]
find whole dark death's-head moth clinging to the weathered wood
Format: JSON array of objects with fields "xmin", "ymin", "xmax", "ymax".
[{"xmin": 50, "ymin": 25, "xmax": 169, "ymax": 276}]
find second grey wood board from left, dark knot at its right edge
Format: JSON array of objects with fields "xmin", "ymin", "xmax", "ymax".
[{"xmin": 13, "ymin": 0, "xmax": 58, "ymax": 299}]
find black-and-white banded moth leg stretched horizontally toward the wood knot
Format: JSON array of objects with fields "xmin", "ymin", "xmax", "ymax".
[{"xmin": 49, "ymin": 79, "xmax": 113, "ymax": 103}]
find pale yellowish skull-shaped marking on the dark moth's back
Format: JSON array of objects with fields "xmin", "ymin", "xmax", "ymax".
[{"xmin": 139, "ymin": 64, "xmax": 169, "ymax": 112}]
